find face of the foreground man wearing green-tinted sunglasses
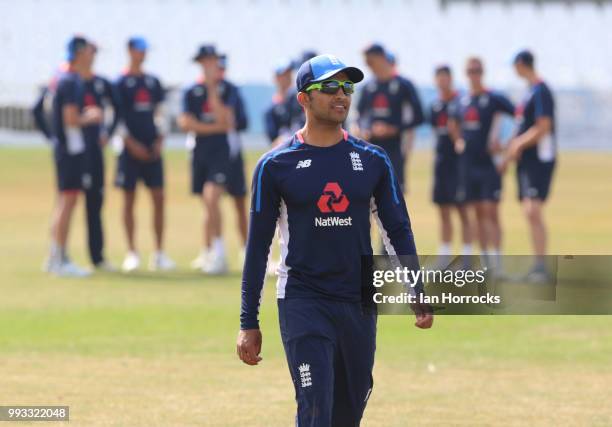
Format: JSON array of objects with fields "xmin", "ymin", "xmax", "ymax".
[{"xmin": 304, "ymin": 73, "xmax": 351, "ymax": 124}]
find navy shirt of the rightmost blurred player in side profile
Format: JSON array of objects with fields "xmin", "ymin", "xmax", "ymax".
[{"xmin": 515, "ymin": 81, "xmax": 557, "ymax": 164}]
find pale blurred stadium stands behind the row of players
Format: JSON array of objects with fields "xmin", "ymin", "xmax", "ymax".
[{"xmin": 0, "ymin": 0, "xmax": 612, "ymax": 149}]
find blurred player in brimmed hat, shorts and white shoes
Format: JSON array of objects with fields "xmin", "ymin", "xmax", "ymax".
[{"xmin": 178, "ymin": 45, "xmax": 236, "ymax": 274}]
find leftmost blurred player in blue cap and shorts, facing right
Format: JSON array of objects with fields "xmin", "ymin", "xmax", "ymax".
[{"xmin": 40, "ymin": 36, "xmax": 102, "ymax": 277}]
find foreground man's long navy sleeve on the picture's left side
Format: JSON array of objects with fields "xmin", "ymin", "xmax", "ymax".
[{"xmin": 240, "ymin": 154, "xmax": 281, "ymax": 329}]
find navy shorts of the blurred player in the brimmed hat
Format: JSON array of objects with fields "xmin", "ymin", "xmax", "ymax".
[{"xmin": 191, "ymin": 142, "xmax": 230, "ymax": 194}]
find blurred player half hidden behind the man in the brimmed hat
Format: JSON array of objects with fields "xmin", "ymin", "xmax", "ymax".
[{"xmin": 218, "ymin": 54, "xmax": 249, "ymax": 266}]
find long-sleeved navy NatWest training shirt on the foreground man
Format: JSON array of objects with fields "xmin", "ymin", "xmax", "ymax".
[{"xmin": 240, "ymin": 132, "xmax": 416, "ymax": 329}]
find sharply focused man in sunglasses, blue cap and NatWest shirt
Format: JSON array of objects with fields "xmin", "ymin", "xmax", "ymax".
[{"xmin": 237, "ymin": 55, "xmax": 433, "ymax": 427}]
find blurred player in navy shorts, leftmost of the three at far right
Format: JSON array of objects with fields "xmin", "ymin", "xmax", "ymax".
[{"xmin": 429, "ymin": 65, "xmax": 472, "ymax": 259}]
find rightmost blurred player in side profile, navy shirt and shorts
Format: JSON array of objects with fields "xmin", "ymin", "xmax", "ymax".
[{"xmin": 506, "ymin": 50, "xmax": 557, "ymax": 281}]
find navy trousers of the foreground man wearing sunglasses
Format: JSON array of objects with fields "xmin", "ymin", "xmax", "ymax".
[{"xmin": 278, "ymin": 298, "xmax": 376, "ymax": 427}]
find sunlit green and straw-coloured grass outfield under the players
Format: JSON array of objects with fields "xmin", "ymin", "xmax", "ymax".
[{"xmin": 0, "ymin": 147, "xmax": 612, "ymax": 427}]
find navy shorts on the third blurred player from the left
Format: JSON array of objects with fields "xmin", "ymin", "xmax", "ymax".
[{"xmin": 115, "ymin": 150, "xmax": 164, "ymax": 191}]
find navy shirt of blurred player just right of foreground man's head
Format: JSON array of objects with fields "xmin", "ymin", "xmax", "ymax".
[{"xmin": 357, "ymin": 76, "xmax": 424, "ymax": 143}]
